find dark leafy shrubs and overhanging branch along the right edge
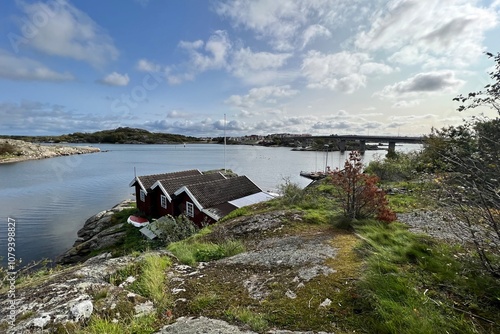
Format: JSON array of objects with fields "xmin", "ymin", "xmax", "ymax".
[{"xmin": 423, "ymin": 53, "xmax": 500, "ymax": 278}]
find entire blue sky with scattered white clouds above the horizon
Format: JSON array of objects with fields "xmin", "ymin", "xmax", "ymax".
[{"xmin": 0, "ymin": 0, "xmax": 500, "ymax": 137}]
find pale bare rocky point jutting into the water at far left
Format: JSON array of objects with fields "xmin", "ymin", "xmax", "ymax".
[{"xmin": 0, "ymin": 139, "xmax": 101, "ymax": 164}]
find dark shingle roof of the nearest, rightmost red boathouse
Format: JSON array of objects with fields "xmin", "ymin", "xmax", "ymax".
[{"xmin": 183, "ymin": 176, "xmax": 262, "ymax": 208}]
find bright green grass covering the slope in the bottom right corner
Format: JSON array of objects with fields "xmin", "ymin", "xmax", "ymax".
[{"xmin": 356, "ymin": 221, "xmax": 500, "ymax": 333}]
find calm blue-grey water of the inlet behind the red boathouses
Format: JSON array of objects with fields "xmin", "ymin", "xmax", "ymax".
[{"xmin": 0, "ymin": 144, "xmax": 418, "ymax": 265}]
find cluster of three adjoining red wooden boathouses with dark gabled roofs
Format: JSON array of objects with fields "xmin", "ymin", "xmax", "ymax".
[{"xmin": 130, "ymin": 170, "xmax": 274, "ymax": 226}]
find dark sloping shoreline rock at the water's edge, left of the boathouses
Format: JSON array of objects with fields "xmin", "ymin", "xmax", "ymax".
[{"xmin": 56, "ymin": 200, "xmax": 132, "ymax": 264}]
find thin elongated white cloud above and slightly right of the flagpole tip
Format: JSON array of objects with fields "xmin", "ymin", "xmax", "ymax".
[{"xmin": 225, "ymin": 85, "xmax": 298, "ymax": 108}]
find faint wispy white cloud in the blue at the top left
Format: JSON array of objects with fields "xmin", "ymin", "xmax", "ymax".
[{"xmin": 16, "ymin": 0, "xmax": 119, "ymax": 66}]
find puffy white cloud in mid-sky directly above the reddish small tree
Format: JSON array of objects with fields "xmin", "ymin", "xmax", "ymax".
[{"xmin": 301, "ymin": 51, "xmax": 392, "ymax": 93}]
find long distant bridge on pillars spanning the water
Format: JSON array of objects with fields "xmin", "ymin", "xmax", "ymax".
[{"xmin": 287, "ymin": 135, "xmax": 424, "ymax": 152}]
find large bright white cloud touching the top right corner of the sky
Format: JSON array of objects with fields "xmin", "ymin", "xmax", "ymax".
[{"xmin": 355, "ymin": 0, "xmax": 498, "ymax": 68}]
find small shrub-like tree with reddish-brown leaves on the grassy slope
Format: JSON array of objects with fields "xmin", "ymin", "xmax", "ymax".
[{"xmin": 331, "ymin": 151, "xmax": 396, "ymax": 222}]
